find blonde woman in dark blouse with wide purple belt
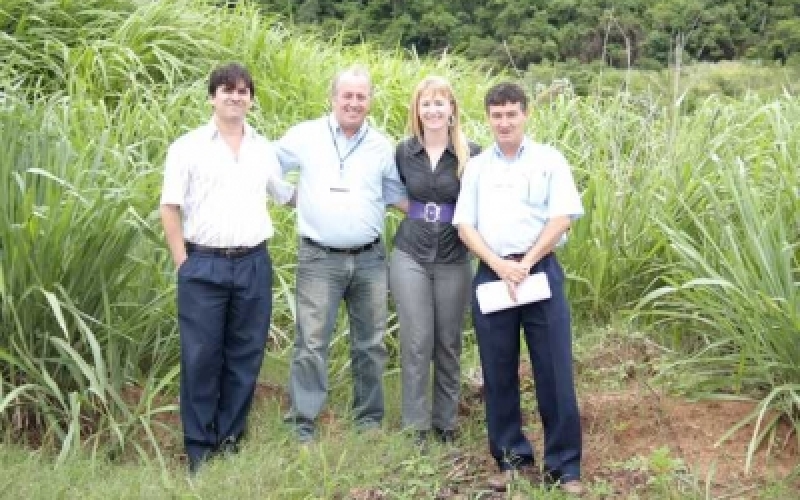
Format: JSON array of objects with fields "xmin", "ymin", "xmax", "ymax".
[{"xmin": 389, "ymin": 76, "xmax": 480, "ymax": 444}]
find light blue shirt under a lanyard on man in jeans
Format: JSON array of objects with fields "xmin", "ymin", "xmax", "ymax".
[{"xmin": 277, "ymin": 115, "xmax": 407, "ymax": 248}]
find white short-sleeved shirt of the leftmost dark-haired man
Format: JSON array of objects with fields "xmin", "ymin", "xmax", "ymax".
[{"xmin": 161, "ymin": 119, "xmax": 294, "ymax": 248}]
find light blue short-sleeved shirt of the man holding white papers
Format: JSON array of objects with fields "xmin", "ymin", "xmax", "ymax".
[{"xmin": 453, "ymin": 137, "xmax": 583, "ymax": 256}]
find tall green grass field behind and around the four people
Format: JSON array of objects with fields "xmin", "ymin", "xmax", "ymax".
[{"xmin": 0, "ymin": 0, "xmax": 800, "ymax": 492}]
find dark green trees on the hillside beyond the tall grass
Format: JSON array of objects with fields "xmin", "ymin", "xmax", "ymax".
[{"xmin": 253, "ymin": 0, "xmax": 800, "ymax": 69}]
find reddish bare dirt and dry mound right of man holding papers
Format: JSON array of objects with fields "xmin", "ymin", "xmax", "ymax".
[{"xmin": 572, "ymin": 341, "xmax": 800, "ymax": 498}]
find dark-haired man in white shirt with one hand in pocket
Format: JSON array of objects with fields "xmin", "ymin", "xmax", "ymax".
[{"xmin": 161, "ymin": 64, "xmax": 294, "ymax": 474}]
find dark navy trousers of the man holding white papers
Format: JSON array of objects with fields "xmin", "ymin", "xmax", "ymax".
[{"xmin": 472, "ymin": 254, "xmax": 581, "ymax": 481}]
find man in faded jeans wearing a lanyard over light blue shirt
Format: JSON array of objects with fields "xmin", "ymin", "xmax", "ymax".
[{"xmin": 278, "ymin": 66, "xmax": 407, "ymax": 443}]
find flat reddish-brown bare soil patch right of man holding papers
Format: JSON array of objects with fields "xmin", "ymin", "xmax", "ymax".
[{"xmin": 580, "ymin": 386, "xmax": 800, "ymax": 496}]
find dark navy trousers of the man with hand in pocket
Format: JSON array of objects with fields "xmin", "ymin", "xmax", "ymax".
[{"xmin": 178, "ymin": 248, "xmax": 272, "ymax": 460}]
